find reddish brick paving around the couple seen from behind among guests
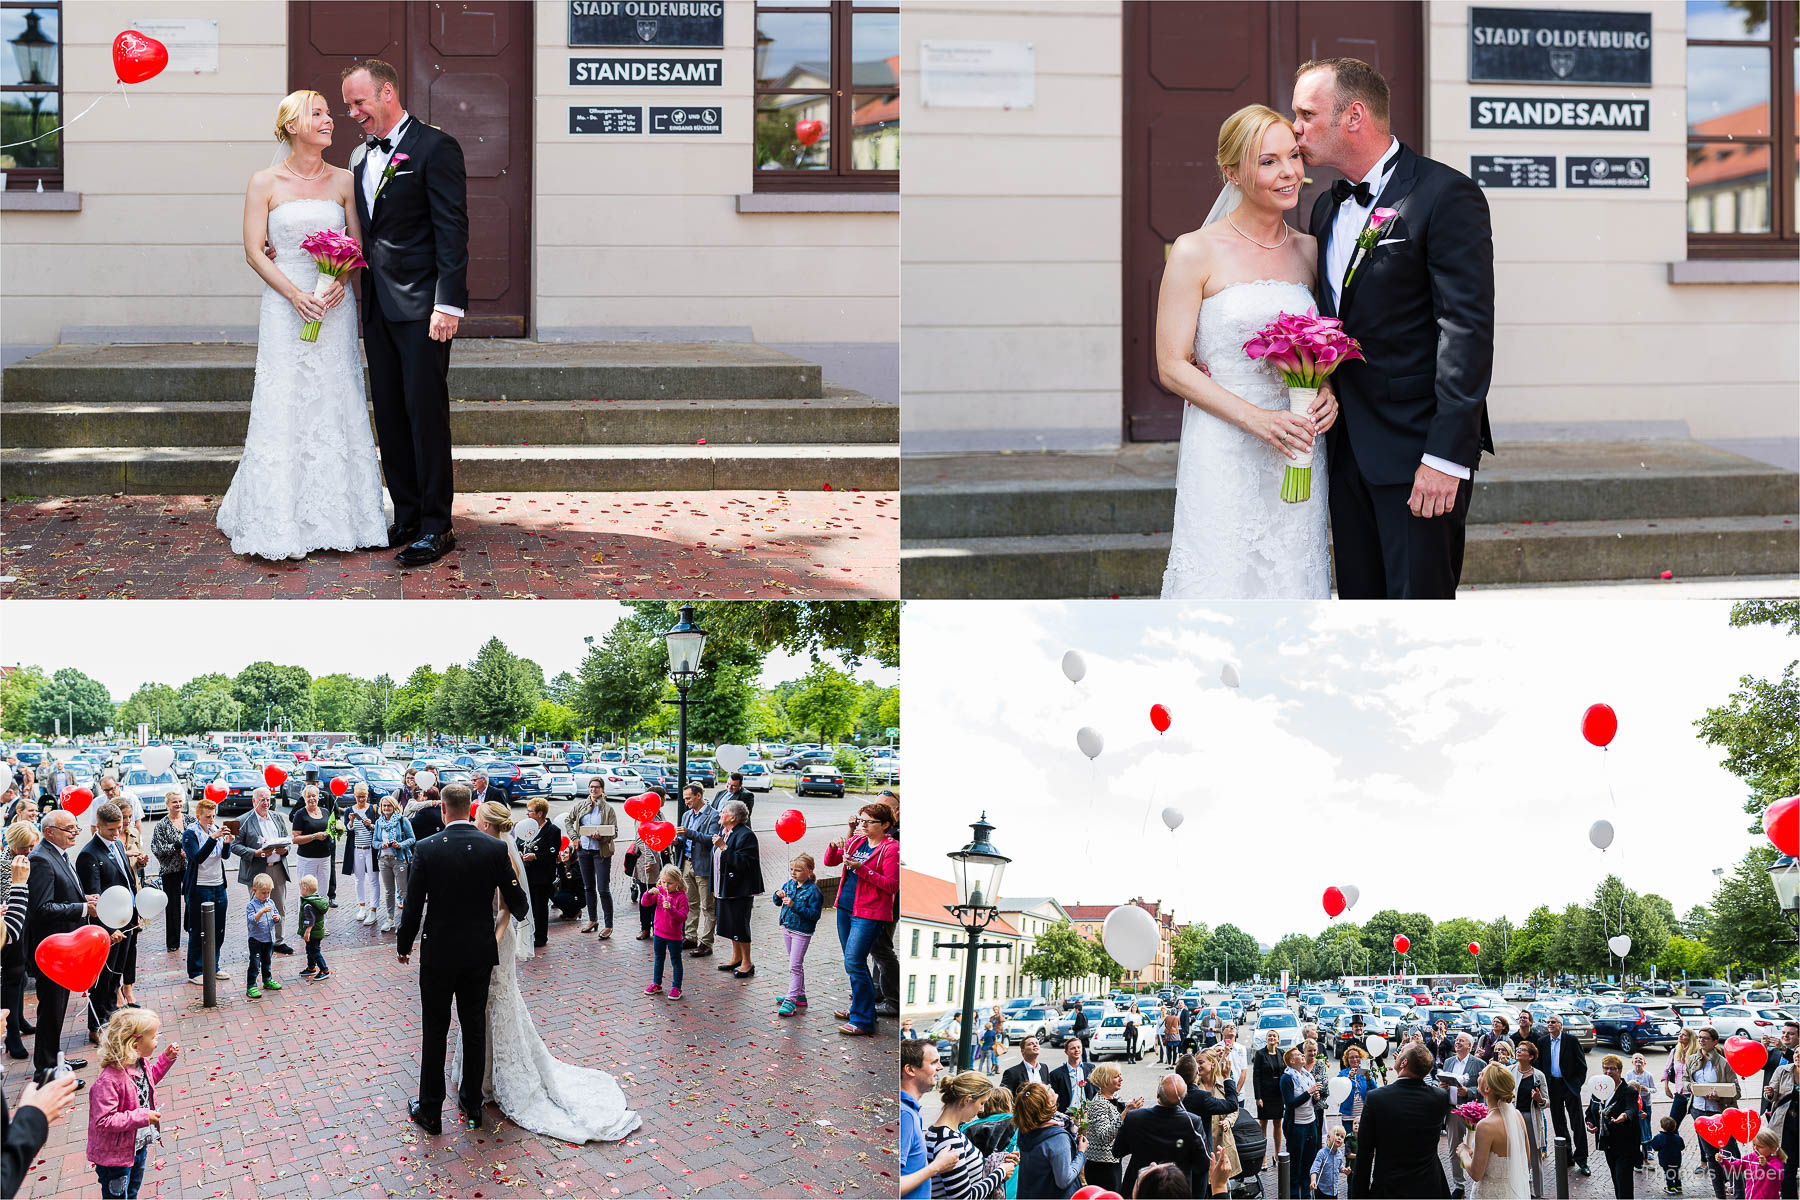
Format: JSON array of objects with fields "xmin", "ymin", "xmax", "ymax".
[{"xmin": 7, "ymin": 829, "xmax": 898, "ymax": 1200}]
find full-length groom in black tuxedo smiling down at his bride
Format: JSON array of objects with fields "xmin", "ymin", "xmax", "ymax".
[{"xmin": 344, "ymin": 58, "xmax": 468, "ymax": 567}]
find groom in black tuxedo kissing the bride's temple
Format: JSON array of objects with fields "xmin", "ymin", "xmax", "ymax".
[{"xmin": 1294, "ymin": 58, "xmax": 1494, "ymax": 599}]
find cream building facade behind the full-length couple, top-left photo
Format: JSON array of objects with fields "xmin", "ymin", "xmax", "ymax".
[{"xmin": 0, "ymin": 0, "xmax": 900, "ymax": 365}]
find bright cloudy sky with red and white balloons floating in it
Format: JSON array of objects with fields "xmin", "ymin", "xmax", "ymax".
[{"xmin": 902, "ymin": 597, "xmax": 1800, "ymax": 943}]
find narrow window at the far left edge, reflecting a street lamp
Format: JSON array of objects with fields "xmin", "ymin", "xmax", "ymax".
[{"xmin": 0, "ymin": 4, "xmax": 63, "ymax": 191}]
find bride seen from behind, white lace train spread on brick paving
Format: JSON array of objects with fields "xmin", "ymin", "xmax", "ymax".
[{"xmin": 450, "ymin": 801, "xmax": 639, "ymax": 1144}]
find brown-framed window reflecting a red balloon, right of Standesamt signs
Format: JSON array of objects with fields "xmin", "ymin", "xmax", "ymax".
[{"xmin": 756, "ymin": 0, "xmax": 900, "ymax": 191}]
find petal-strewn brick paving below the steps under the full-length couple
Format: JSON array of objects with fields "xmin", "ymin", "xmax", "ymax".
[{"xmin": 0, "ymin": 489, "xmax": 900, "ymax": 599}]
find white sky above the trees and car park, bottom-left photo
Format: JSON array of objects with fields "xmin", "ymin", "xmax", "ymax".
[{"xmin": 0, "ymin": 601, "xmax": 900, "ymax": 702}]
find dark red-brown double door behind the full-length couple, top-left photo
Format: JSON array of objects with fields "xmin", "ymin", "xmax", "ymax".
[{"xmin": 288, "ymin": 0, "xmax": 533, "ymax": 338}]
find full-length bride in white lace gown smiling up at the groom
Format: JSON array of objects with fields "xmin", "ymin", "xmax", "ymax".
[{"xmin": 218, "ymin": 92, "xmax": 387, "ymax": 560}]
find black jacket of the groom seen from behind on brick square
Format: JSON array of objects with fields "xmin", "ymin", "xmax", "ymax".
[{"xmin": 396, "ymin": 822, "xmax": 529, "ymax": 970}]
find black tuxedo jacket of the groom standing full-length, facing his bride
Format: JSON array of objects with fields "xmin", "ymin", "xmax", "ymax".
[{"xmin": 349, "ymin": 113, "xmax": 468, "ymax": 320}]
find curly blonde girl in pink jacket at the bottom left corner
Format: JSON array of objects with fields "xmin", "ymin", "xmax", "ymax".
[{"xmin": 88, "ymin": 1007, "xmax": 182, "ymax": 1200}]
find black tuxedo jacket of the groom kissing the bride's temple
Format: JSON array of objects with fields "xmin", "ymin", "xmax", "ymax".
[{"xmin": 1309, "ymin": 146, "xmax": 1494, "ymax": 486}]
